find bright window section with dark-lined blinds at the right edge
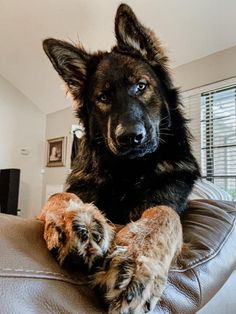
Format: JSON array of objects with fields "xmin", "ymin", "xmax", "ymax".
[{"xmin": 201, "ymin": 85, "xmax": 236, "ymax": 199}]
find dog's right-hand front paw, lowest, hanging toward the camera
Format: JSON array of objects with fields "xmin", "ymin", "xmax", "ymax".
[{"xmin": 94, "ymin": 230, "xmax": 169, "ymax": 314}]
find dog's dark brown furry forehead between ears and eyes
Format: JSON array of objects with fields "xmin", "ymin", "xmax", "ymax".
[{"xmin": 95, "ymin": 53, "xmax": 154, "ymax": 85}]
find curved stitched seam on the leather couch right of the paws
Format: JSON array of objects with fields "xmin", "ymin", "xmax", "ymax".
[{"xmin": 170, "ymin": 218, "xmax": 236, "ymax": 272}]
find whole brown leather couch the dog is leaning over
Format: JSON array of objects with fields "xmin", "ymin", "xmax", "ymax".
[{"xmin": 0, "ymin": 200, "xmax": 236, "ymax": 314}]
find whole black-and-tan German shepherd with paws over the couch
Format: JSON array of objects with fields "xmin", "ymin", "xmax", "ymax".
[{"xmin": 39, "ymin": 4, "xmax": 200, "ymax": 314}]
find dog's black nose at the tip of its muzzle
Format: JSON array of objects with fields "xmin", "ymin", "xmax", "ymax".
[{"xmin": 115, "ymin": 124, "xmax": 146, "ymax": 146}]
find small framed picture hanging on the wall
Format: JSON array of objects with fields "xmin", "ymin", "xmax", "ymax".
[{"xmin": 46, "ymin": 137, "xmax": 66, "ymax": 167}]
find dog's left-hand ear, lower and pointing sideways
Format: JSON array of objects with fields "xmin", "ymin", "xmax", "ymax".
[{"xmin": 43, "ymin": 38, "xmax": 90, "ymax": 97}]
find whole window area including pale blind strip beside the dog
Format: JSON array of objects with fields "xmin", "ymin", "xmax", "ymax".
[{"xmin": 182, "ymin": 78, "xmax": 236, "ymax": 200}]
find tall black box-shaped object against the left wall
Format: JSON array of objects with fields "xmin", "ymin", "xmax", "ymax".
[{"xmin": 0, "ymin": 169, "xmax": 20, "ymax": 215}]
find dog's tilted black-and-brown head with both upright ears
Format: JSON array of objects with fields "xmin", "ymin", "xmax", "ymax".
[{"xmin": 43, "ymin": 4, "xmax": 176, "ymax": 158}]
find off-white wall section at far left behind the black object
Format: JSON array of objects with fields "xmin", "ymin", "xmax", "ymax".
[{"xmin": 0, "ymin": 76, "xmax": 46, "ymax": 217}]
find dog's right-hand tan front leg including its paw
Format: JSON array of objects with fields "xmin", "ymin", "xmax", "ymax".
[{"xmin": 95, "ymin": 206, "xmax": 182, "ymax": 314}]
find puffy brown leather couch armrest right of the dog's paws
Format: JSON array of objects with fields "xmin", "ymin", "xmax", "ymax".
[{"xmin": 155, "ymin": 200, "xmax": 236, "ymax": 314}]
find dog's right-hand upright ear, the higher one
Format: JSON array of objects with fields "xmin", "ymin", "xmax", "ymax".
[{"xmin": 115, "ymin": 4, "xmax": 168, "ymax": 66}]
